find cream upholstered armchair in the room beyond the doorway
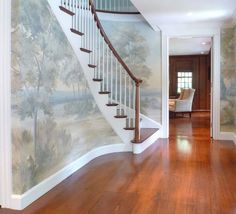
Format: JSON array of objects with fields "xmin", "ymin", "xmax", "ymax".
[{"xmin": 169, "ymin": 88, "xmax": 195, "ymax": 117}]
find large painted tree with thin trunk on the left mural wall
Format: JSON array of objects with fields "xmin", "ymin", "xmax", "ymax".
[{"xmin": 12, "ymin": 0, "xmax": 78, "ymax": 161}]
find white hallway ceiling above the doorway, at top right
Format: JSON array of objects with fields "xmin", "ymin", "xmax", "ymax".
[{"xmin": 131, "ymin": 0, "xmax": 236, "ymax": 29}]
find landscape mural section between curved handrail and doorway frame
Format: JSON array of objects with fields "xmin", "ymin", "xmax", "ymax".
[{"xmin": 102, "ymin": 20, "xmax": 161, "ymax": 123}]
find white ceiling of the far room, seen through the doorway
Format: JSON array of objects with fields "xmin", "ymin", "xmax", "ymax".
[{"xmin": 169, "ymin": 37, "xmax": 212, "ymax": 55}]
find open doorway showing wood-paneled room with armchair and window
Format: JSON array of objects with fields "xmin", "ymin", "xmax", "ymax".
[{"xmin": 169, "ymin": 37, "xmax": 212, "ymax": 136}]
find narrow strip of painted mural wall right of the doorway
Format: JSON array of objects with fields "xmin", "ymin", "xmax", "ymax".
[{"xmin": 220, "ymin": 27, "xmax": 236, "ymax": 133}]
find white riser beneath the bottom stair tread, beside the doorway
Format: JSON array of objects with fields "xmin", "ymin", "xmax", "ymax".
[{"xmin": 133, "ymin": 130, "xmax": 161, "ymax": 154}]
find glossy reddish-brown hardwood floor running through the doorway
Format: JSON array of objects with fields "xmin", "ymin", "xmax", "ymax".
[{"xmin": 0, "ymin": 113, "xmax": 236, "ymax": 214}]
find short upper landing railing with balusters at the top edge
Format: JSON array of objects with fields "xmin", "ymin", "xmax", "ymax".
[{"xmin": 94, "ymin": 0, "xmax": 139, "ymax": 14}]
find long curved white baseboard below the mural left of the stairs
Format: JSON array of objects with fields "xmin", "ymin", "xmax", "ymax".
[{"xmin": 10, "ymin": 143, "xmax": 132, "ymax": 210}]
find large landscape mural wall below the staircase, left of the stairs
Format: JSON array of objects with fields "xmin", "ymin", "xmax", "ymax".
[{"xmin": 11, "ymin": 0, "xmax": 122, "ymax": 194}]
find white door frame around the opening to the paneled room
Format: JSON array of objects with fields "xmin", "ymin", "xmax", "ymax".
[{"xmin": 162, "ymin": 25, "xmax": 220, "ymax": 139}]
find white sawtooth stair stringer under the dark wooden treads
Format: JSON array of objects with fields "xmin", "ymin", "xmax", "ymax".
[{"xmin": 48, "ymin": 0, "xmax": 134, "ymax": 145}]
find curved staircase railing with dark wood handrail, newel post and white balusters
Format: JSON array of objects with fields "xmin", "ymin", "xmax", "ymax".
[{"xmin": 60, "ymin": 0, "xmax": 142, "ymax": 143}]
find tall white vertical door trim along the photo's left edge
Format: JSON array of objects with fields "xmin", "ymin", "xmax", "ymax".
[{"xmin": 0, "ymin": 0, "xmax": 12, "ymax": 207}]
